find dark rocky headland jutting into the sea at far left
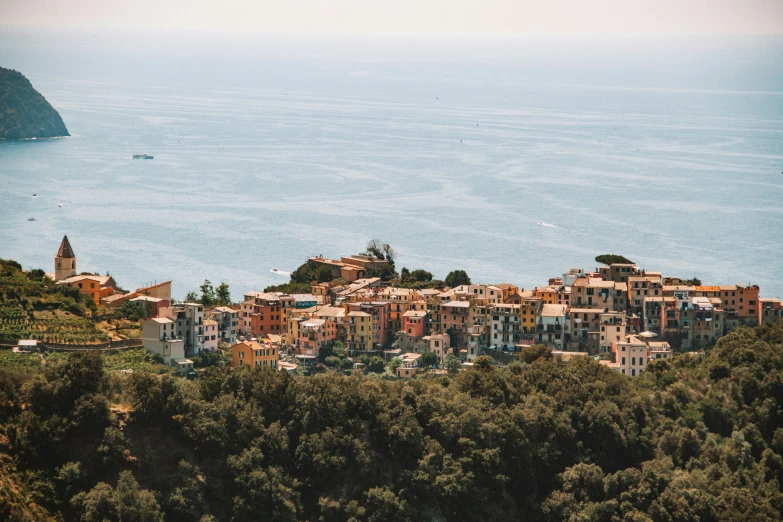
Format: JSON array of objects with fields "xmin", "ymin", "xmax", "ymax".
[{"xmin": 0, "ymin": 67, "xmax": 70, "ymax": 140}]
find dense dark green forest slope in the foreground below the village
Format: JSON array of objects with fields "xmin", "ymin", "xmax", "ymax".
[{"xmin": 0, "ymin": 323, "xmax": 783, "ymax": 522}]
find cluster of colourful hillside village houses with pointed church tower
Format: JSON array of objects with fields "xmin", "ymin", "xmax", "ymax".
[{"xmin": 49, "ymin": 238, "xmax": 783, "ymax": 377}]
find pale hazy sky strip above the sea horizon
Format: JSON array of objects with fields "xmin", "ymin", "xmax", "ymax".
[{"xmin": 0, "ymin": 0, "xmax": 783, "ymax": 35}]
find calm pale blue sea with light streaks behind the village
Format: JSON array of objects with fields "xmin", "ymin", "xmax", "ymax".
[{"xmin": 0, "ymin": 28, "xmax": 783, "ymax": 299}]
